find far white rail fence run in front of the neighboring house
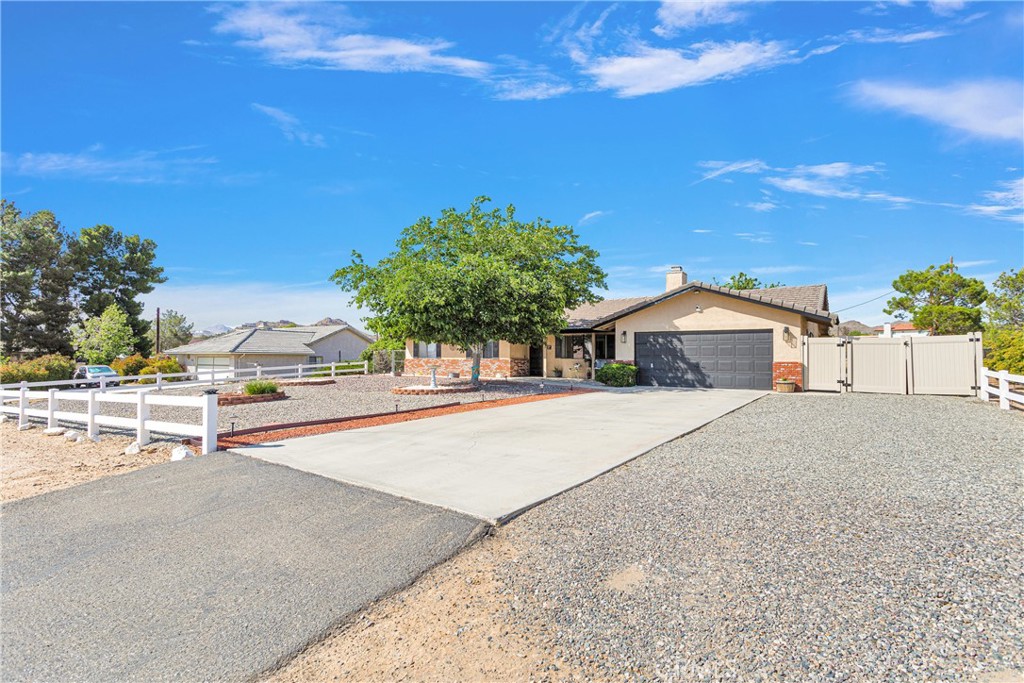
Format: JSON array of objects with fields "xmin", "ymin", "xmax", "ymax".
[{"xmin": 0, "ymin": 360, "xmax": 369, "ymax": 393}]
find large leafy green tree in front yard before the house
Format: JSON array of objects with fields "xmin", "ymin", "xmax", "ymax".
[{"xmin": 331, "ymin": 197, "xmax": 605, "ymax": 383}]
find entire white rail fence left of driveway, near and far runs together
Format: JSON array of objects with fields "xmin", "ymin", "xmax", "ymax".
[{"xmin": 0, "ymin": 361, "xmax": 368, "ymax": 455}]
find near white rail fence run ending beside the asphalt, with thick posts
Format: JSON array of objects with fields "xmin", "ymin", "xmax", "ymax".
[{"xmin": 0, "ymin": 383, "xmax": 217, "ymax": 455}]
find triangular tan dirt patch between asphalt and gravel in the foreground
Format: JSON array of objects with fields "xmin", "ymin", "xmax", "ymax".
[{"xmin": 263, "ymin": 529, "xmax": 601, "ymax": 683}]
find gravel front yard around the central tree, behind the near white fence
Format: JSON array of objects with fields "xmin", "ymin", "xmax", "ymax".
[{"xmin": 68, "ymin": 375, "xmax": 564, "ymax": 431}]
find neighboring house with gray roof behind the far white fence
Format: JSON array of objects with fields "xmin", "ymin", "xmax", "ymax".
[{"xmin": 165, "ymin": 324, "xmax": 374, "ymax": 372}]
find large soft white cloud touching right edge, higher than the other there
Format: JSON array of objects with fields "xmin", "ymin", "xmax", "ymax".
[{"xmin": 853, "ymin": 80, "xmax": 1024, "ymax": 141}]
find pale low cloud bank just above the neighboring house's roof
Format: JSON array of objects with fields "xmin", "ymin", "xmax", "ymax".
[{"xmin": 141, "ymin": 282, "xmax": 367, "ymax": 330}]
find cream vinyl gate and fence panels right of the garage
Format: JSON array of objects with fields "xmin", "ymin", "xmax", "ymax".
[{"xmin": 803, "ymin": 333, "xmax": 982, "ymax": 396}]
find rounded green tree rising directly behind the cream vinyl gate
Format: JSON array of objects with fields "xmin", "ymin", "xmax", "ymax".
[{"xmin": 884, "ymin": 262, "xmax": 988, "ymax": 335}]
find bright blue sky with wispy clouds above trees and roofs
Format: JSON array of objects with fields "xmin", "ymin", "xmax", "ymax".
[{"xmin": 0, "ymin": 1, "xmax": 1024, "ymax": 328}]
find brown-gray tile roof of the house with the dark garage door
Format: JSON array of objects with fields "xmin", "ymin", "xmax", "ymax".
[{"xmin": 565, "ymin": 280, "xmax": 839, "ymax": 330}]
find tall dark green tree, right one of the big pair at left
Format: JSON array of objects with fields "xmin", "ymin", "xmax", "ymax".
[{"xmin": 71, "ymin": 225, "xmax": 167, "ymax": 356}]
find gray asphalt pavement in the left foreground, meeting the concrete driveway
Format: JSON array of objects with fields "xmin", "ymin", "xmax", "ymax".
[{"xmin": 0, "ymin": 453, "xmax": 479, "ymax": 682}]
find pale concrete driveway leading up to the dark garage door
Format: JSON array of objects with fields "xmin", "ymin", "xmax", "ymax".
[{"xmin": 236, "ymin": 389, "xmax": 766, "ymax": 522}]
